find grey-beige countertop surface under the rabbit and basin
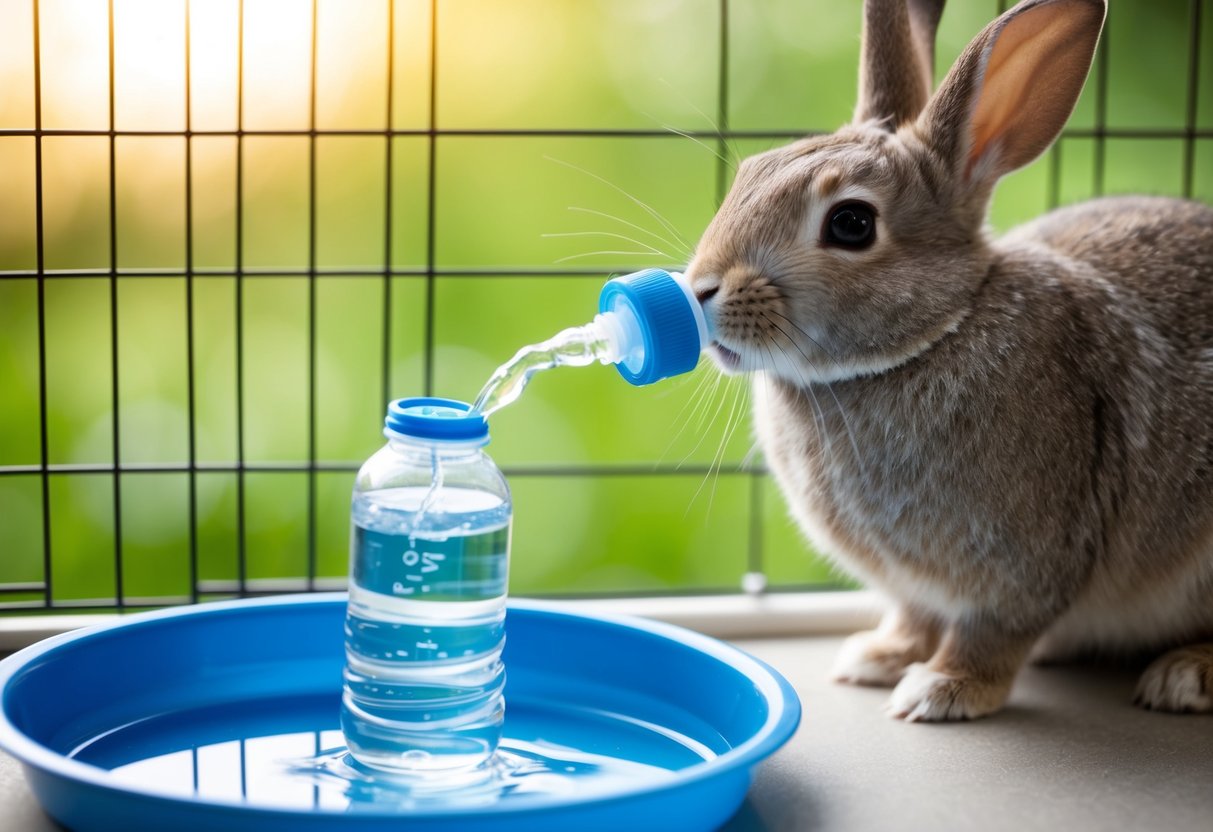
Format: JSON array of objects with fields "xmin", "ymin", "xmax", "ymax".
[{"xmin": 0, "ymin": 637, "xmax": 1213, "ymax": 832}]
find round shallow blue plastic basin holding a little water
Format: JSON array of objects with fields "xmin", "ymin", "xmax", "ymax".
[{"xmin": 0, "ymin": 594, "xmax": 801, "ymax": 832}]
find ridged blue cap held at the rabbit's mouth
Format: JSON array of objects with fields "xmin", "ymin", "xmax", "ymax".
[{"xmin": 598, "ymin": 269, "xmax": 702, "ymax": 386}]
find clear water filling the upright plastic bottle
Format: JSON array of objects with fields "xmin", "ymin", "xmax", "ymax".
[{"xmin": 341, "ymin": 483, "xmax": 509, "ymax": 783}]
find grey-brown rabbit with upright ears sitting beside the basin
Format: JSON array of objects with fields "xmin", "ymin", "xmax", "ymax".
[{"xmin": 685, "ymin": 0, "xmax": 1213, "ymax": 722}]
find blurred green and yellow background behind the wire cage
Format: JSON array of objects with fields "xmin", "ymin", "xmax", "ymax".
[{"xmin": 0, "ymin": 0, "xmax": 1213, "ymax": 608}]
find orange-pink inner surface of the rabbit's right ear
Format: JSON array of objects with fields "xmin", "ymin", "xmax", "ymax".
[{"xmin": 966, "ymin": 0, "xmax": 1100, "ymax": 177}]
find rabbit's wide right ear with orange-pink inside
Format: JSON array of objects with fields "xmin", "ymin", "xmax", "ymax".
[{"xmin": 918, "ymin": 0, "xmax": 1105, "ymax": 187}]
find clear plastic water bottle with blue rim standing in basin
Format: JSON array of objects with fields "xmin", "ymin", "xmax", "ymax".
[{"xmin": 341, "ymin": 398, "xmax": 512, "ymax": 782}]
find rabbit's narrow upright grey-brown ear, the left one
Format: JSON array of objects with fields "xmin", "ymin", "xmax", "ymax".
[{"xmin": 855, "ymin": 0, "xmax": 944, "ymax": 131}]
